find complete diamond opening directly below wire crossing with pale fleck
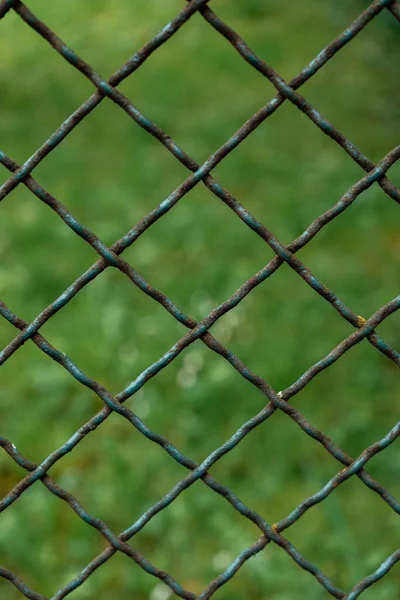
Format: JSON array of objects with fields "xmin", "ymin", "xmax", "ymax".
[{"xmin": 211, "ymin": 400, "xmax": 338, "ymax": 524}]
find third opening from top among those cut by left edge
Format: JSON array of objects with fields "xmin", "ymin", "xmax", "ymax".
[{"xmin": 0, "ymin": 340, "xmax": 97, "ymax": 462}]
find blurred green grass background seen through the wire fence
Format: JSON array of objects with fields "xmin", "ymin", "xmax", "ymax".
[{"xmin": 0, "ymin": 0, "xmax": 400, "ymax": 600}]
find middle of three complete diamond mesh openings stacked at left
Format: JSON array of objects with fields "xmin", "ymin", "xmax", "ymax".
[{"xmin": 37, "ymin": 269, "xmax": 186, "ymax": 394}]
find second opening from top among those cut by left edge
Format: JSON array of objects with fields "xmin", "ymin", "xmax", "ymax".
[{"xmin": 0, "ymin": 186, "xmax": 98, "ymax": 322}]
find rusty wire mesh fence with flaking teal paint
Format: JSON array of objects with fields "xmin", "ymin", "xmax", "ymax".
[{"xmin": 0, "ymin": 0, "xmax": 400, "ymax": 600}]
